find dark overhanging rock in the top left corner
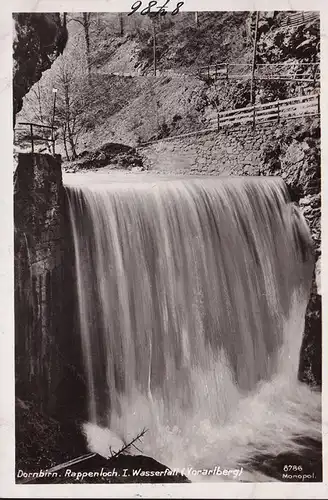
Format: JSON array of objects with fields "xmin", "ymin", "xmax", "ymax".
[{"xmin": 13, "ymin": 12, "xmax": 68, "ymax": 123}]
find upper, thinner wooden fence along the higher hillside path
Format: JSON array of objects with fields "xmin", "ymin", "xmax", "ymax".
[{"xmin": 197, "ymin": 62, "xmax": 320, "ymax": 83}]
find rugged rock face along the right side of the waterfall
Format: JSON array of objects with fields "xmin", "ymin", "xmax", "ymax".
[{"xmin": 261, "ymin": 119, "xmax": 322, "ymax": 388}]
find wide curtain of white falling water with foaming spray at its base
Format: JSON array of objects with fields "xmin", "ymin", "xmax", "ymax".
[{"xmin": 66, "ymin": 176, "xmax": 320, "ymax": 477}]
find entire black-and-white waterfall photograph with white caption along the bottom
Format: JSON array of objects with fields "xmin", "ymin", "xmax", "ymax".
[{"xmin": 5, "ymin": 0, "xmax": 324, "ymax": 498}]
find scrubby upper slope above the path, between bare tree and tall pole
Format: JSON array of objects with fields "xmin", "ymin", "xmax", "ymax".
[{"xmin": 92, "ymin": 12, "xmax": 252, "ymax": 74}]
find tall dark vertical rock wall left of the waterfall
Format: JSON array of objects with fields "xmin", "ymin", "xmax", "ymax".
[{"xmin": 14, "ymin": 154, "xmax": 84, "ymax": 417}]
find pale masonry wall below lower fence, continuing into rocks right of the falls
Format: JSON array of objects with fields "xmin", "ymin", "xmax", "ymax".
[{"xmin": 138, "ymin": 117, "xmax": 321, "ymax": 386}]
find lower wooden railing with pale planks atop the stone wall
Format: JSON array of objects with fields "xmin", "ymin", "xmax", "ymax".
[{"xmin": 210, "ymin": 94, "xmax": 320, "ymax": 130}]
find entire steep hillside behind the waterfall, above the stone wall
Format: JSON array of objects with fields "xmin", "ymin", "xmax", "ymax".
[{"xmin": 16, "ymin": 12, "xmax": 320, "ymax": 159}]
